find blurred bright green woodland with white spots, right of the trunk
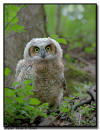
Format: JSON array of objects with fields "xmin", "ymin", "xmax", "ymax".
[{"xmin": 44, "ymin": 4, "xmax": 96, "ymax": 53}]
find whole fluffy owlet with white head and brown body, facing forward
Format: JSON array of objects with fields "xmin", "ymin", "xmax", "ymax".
[{"xmin": 15, "ymin": 37, "xmax": 65, "ymax": 106}]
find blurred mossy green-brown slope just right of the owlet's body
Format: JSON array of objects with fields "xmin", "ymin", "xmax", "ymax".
[{"xmin": 65, "ymin": 63, "xmax": 95, "ymax": 96}]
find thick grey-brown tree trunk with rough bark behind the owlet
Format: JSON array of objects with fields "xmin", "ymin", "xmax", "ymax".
[{"xmin": 4, "ymin": 5, "xmax": 46, "ymax": 87}]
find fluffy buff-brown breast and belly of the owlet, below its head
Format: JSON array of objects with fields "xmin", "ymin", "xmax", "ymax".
[{"xmin": 33, "ymin": 59, "xmax": 64, "ymax": 105}]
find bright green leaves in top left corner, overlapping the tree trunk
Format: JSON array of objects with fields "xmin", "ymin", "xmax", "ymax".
[{"xmin": 4, "ymin": 4, "xmax": 25, "ymax": 34}]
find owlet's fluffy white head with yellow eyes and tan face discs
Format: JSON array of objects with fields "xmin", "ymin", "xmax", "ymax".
[{"xmin": 24, "ymin": 37, "xmax": 62, "ymax": 61}]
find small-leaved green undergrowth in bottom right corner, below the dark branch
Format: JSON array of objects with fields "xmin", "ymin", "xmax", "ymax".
[{"xmin": 60, "ymin": 97, "xmax": 96, "ymax": 126}]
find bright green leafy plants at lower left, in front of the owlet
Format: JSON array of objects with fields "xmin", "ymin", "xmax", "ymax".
[{"xmin": 4, "ymin": 77, "xmax": 48, "ymax": 126}]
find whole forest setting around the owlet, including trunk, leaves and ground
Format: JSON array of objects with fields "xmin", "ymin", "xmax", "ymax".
[{"xmin": 4, "ymin": 4, "xmax": 97, "ymax": 126}]
